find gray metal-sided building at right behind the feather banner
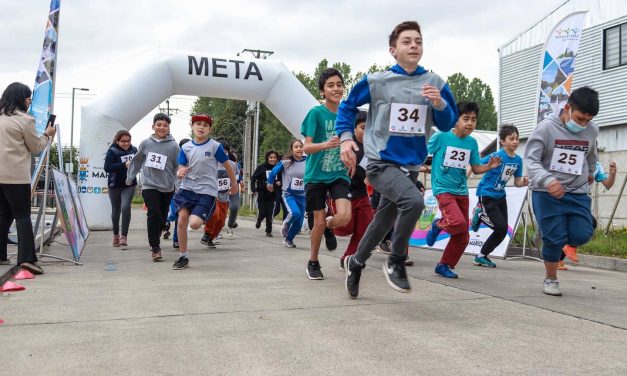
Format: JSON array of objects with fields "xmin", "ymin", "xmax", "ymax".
[{"xmin": 498, "ymin": 0, "xmax": 627, "ymax": 227}]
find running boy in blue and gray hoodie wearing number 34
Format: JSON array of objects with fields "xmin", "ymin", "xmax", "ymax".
[{"xmin": 335, "ymin": 21, "xmax": 457, "ymax": 299}]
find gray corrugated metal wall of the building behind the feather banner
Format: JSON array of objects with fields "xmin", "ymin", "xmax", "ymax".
[{"xmin": 499, "ymin": 16, "xmax": 627, "ymax": 151}]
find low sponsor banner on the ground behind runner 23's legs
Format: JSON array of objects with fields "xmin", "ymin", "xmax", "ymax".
[{"xmin": 409, "ymin": 187, "xmax": 527, "ymax": 257}]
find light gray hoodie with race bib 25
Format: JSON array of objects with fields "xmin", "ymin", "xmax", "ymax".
[{"xmin": 525, "ymin": 115, "xmax": 599, "ymax": 193}]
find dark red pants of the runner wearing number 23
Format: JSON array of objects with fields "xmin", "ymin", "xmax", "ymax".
[{"xmin": 436, "ymin": 193, "xmax": 470, "ymax": 268}]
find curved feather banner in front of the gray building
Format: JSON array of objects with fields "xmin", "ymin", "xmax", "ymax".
[{"xmin": 537, "ymin": 12, "xmax": 586, "ymax": 123}]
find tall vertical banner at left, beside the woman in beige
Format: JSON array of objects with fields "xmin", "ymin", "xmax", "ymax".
[{"xmin": 29, "ymin": 0, "xmax": 61, "ymax": 133}]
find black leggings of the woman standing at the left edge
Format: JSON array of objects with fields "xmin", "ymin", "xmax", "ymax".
[{"xmin": 0, "ymin": 184, "xmax": 37, "ymax": 265}]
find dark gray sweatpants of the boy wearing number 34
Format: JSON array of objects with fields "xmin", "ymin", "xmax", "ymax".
[{"xmin": 355, "ymin": 161, "xmax": 425, "ymax": 265}]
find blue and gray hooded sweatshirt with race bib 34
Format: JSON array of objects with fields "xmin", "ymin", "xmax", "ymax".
[{"xmin": 335, "ymin": 65, "xmax": 458, "ymax": 171}]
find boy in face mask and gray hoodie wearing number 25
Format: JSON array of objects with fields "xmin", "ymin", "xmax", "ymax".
[{"xmin": 525, "ymin": 87, "xmax": 599, "ymax": 296}]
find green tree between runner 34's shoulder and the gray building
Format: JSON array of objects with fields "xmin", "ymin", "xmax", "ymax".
[{"xmin": 447, "ymin": 73, "xmax": 497, "ymax": 131}]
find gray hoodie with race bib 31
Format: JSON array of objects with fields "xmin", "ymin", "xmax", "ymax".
[{"xmin": 126, "ymin": 135, "xmax": 181, "ymax": 192}]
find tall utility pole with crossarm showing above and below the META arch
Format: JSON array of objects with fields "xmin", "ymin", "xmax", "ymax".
[{"xmin": 237, "ymin": 48, "xmax": 274, "ymax": 209}]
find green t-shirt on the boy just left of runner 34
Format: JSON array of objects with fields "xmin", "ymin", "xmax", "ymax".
[{"xmin": 300, "ymin": 105, "xmax": 350, "ymax": 183}]
